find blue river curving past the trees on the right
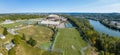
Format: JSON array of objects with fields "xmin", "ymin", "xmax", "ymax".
[{"xmin": 89, "ymin": 20, "xmax": 120, "ymax": 37}]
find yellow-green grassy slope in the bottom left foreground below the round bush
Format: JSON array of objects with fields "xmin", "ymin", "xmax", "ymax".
[{"xmin": 10, "ymin": 36, "xmax": 57, "ymax": 55}]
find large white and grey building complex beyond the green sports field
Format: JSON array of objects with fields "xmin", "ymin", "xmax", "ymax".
[{"xmin": 38, "ymin": 14, "xmax": 67, "ymax": 28}]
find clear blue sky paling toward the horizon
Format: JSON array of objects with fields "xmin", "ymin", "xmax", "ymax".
[{"xmin": 0, "ymin": 0, "xmax": 120, "ymax": 13}]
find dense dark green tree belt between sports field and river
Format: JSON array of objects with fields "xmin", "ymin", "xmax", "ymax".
[{"xmin": 64, "ymin": 15, "xmax": 120, "ymax": 55}]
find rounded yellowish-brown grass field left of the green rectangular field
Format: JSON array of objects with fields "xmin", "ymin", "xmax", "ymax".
[{"xmin": 18, "ymin": 26, "xmax": 53, "ymax": 49}]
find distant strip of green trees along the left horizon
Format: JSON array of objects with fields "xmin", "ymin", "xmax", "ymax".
[{"xmin": 0, "ymin": 14, "xmax": 46, "ymax": 21}]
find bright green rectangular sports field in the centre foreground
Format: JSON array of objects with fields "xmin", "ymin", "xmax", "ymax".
[{"xmin": 53, "ymin": 28, "xmax": 87, "ymax": 55}]
